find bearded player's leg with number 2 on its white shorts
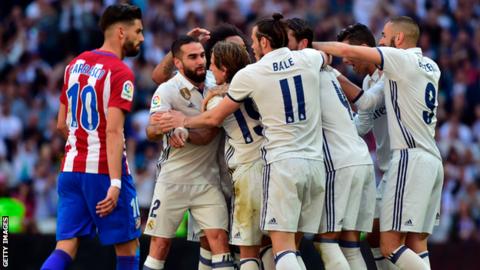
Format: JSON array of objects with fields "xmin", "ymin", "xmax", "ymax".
[{"xmin": 143, "ymin": 182, "xmax": 190, "ymax": 270}]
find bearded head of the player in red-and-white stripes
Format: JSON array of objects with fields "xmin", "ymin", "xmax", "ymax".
[{"xmin": 99, "ymin": 4, "xmax": 144, "ymax": 56}]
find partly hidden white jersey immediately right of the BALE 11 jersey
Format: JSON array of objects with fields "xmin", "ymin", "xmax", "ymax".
[{"xmin": 320, "ymin": 67, "xmax": 373, "ymax": 171}]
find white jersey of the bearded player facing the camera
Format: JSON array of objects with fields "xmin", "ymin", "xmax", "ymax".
[{"xmin": 150, "ymin": 72, "xmax": 220, "ymax": 185}]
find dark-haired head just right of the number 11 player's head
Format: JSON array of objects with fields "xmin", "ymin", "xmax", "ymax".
[{"xmin": 287, "ymin": 18, "xmax": 313, "ymax": 50}]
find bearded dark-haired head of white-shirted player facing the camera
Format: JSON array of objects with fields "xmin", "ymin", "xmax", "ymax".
[{"xmin": 172, "ymin": 35, "xmax": 207, "ymax": 83}]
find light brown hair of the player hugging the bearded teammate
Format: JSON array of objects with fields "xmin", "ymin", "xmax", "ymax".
[{"xmin": 212, "ymin": 41, "xmax": 250, "ymax": 83}]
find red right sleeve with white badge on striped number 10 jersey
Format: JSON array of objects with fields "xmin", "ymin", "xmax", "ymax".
[{"xmin": 108, "ymin": 67, "xmax": 135, "ymax": 112}]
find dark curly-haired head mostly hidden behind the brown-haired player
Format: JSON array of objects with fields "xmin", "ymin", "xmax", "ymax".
[{"xmin": 205, "ymin": 23, "xmax": 249, "ymax": 67}]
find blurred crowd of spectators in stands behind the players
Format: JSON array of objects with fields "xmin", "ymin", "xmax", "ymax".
[{"xmin": 0, "ymin": 0, "xmax": 480, "ymax": 243}]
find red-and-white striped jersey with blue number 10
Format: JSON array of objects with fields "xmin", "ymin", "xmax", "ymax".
[{"xmin": 60, "ymin": 50, "xmax": 134, "ymax": 174}]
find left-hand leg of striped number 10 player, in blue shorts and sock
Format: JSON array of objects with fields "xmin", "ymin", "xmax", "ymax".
[{"xmin": 41, "ymin": 172, "xmax": 95, "ymax": 270}]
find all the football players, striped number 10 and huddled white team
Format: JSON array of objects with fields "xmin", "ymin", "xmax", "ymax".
[{"xmin": 42, "ymin": 2, "xmax": 443, "ymax": 270}]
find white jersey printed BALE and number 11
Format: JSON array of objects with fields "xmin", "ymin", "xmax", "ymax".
[{"xmin": 228, "ymin": 48, "xmax": 323, "ymax": 164}]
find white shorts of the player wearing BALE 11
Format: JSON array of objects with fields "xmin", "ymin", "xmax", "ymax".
[{"xmin": 260, "ymin": 158, "xmax": 325, "ymax": 233}]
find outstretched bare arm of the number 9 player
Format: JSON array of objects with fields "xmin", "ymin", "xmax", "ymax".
[{"xmin": 313, "ymin": 42, "xmax": 383, "ymax": 66}]
